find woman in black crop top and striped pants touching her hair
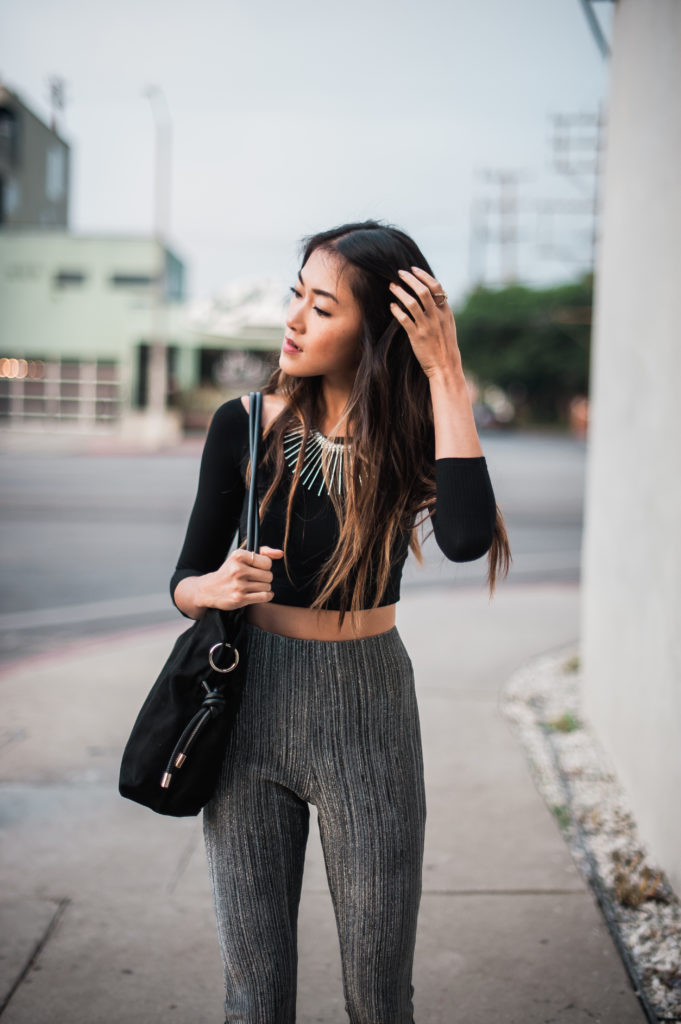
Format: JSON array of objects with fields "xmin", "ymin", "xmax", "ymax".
[{"xmin": 171, "ymin": 220, "xmax": 510, "ymax": 1024}]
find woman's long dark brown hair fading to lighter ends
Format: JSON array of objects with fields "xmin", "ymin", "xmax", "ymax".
[{"xmin": 244, "ymin": 220, "xmax": 512, "ymax": 626}]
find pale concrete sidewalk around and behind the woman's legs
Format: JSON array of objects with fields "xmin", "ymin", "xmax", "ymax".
[{"xmin": 0, "ymin": 584, "xmax": 644, "ymax": 1024}]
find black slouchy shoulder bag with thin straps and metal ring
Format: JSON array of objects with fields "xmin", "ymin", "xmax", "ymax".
[{"xmin": 119, "ymin": 391, "xmax": 262, "ymax": 817}]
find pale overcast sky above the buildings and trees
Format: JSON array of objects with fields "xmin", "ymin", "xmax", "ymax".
[{"xmin": 0, "ymin": 0, "xmax": 614, "ymax": 301}]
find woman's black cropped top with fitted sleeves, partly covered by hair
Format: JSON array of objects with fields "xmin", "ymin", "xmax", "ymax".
[{"xmin": 170, "ymin": 398, "xmax": 497, "ymax": 617}]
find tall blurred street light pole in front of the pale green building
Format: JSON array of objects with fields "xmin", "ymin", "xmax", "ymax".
[{"xmin": 144, "ymin": 85, "xmax": 171, "ymax": 418}]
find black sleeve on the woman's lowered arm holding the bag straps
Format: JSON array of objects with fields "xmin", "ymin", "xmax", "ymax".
[{"xmin": 170, "ymin": 398, "xmax": 248, "ymax": 617}]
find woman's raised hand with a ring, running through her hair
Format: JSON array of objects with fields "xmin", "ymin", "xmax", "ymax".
[{"xmin": 390, "ymin": 266, "xmax": 463, "ymax": 377}]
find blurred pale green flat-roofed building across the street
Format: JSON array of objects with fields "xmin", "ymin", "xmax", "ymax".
[{"xmin": 0, "ymin": 228, "xmax": 188, "ymax": 429}]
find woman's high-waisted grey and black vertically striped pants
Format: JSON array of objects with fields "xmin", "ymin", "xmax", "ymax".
[{"xmin": 203, "ymin": 624, "xmax": 426, "ymax": 1024}]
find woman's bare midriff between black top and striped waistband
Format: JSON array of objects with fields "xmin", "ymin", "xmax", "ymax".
[{"xmin": 246, "ymin": 601, "xmax": 397, "ymax": 640}]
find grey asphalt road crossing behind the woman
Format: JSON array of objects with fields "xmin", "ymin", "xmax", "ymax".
[{"xmin": 0, "ymin": 430, "xmax": 586, "ymax": 663}]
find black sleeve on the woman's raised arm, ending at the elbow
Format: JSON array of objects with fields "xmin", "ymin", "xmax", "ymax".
[{"xmin": 432, "ymin": 455, "xmax": 497, "ymax": 562}]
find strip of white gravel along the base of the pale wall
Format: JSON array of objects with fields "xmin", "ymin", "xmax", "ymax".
[{"xmin": 500, "ymin": 645, "xmax": 681, "ymax": 1022}]
